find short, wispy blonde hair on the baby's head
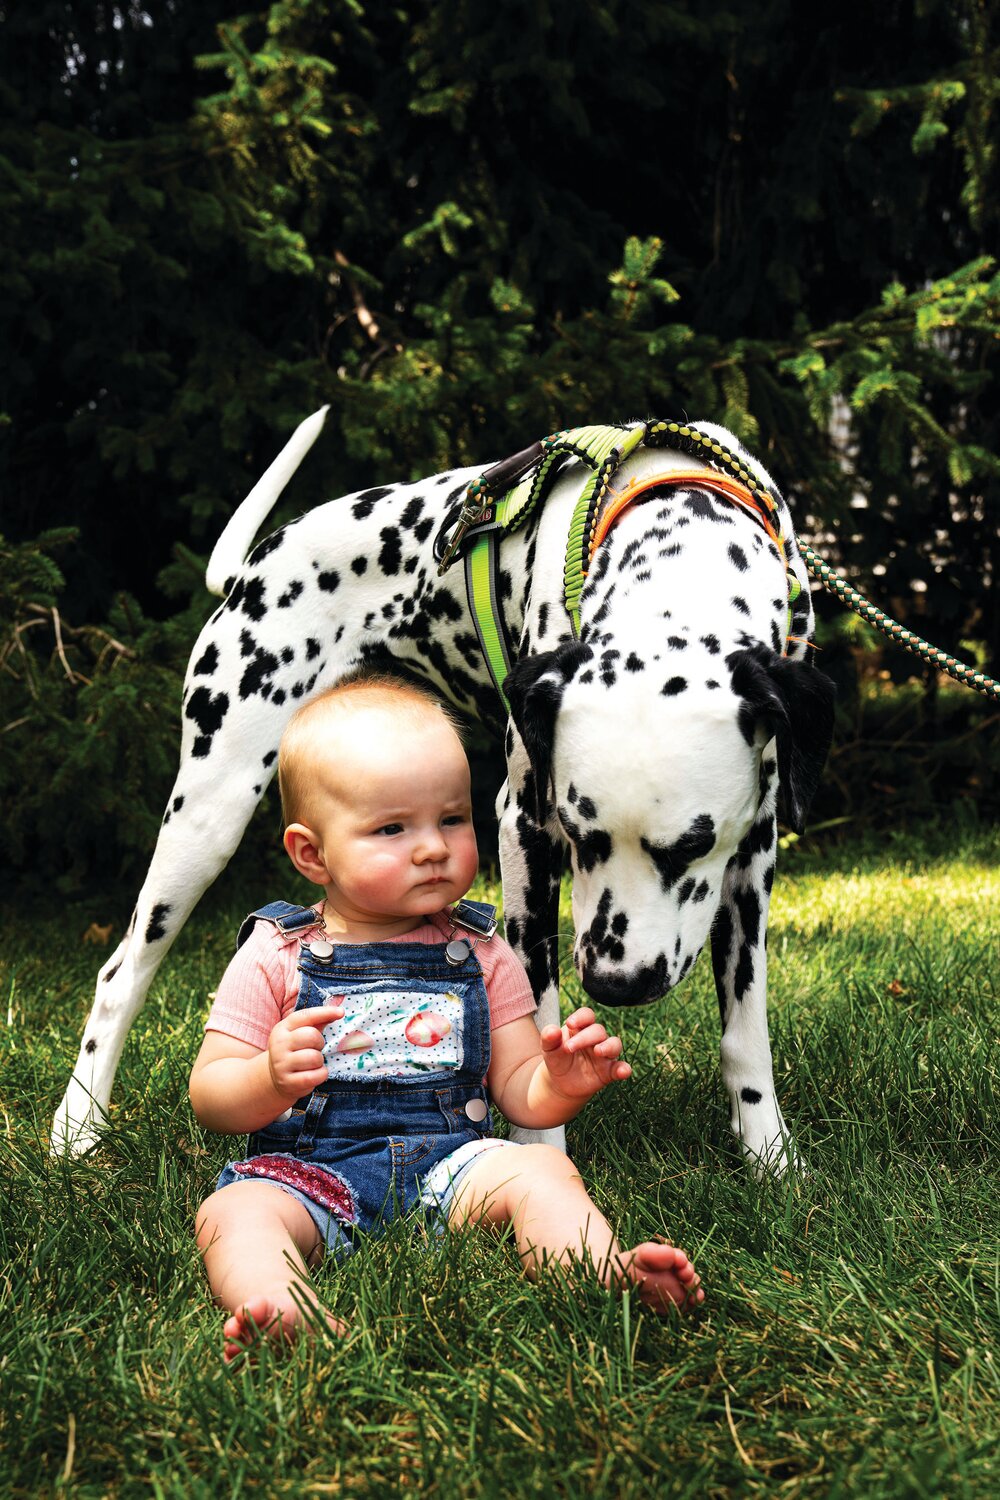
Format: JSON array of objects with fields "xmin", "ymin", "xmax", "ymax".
[{"xmin": 277, "ymin": 668, "xmax": 462, "ymax": 828}]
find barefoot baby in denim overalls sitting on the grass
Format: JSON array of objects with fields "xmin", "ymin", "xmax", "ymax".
[{"xmin": 190, "ymin": 675, "xmax": 705, "ymax": 1361}]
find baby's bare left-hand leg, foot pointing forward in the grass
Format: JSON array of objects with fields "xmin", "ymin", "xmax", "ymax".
[{"xmin": 196, "ymin": 1182, "xmax": 343, "ymax": 1362}]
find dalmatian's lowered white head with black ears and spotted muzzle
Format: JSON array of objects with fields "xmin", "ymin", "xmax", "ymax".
[{"xmin": 505, "ymin": 642, "xmax": 834, "ymax": 1005}]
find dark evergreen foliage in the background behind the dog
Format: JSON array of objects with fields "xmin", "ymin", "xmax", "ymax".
[{"xmin": 0, "ymin": 0, "xmax": 1000, "ymax": 891}]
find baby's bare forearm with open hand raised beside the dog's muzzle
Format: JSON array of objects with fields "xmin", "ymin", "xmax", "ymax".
[{"xmin": 487, "ymin": 1007, "xmax": 631, "ymax": 1130}]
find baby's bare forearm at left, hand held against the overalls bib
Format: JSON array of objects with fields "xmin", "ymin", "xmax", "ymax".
[{"xmin": 189, "ymin": 1002, "xmax": 343, "ymax": 1136}]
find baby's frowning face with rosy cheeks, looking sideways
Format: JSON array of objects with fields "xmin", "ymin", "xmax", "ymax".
[{"xmin": 307, "ymin": 710, "xmax": 478, "ymax": 927}]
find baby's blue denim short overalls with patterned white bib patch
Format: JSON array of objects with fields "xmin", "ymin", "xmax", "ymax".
[{"xmin": 217, "ymin": 902, "xmax": 507, "ymax": 1253}]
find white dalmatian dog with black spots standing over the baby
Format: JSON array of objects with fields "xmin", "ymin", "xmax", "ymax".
[{"xmin": 52, "ymin": 408, "xmax": 832, "ymax": 1173}]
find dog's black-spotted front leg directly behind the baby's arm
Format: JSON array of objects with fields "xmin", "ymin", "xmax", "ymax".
[{"xmin": 496, "ymin": 780, "xmax": 565, "ymax": 1151}]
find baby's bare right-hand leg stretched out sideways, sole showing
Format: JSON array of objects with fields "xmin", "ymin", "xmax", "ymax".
[{"xmin": 448, "ymin": 1146, "xmax": 705, "ymax": 1313}]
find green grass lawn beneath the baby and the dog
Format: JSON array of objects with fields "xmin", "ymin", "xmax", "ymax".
[{"xmin": 0, "ymin": 830, "xmax": 1000, "ymax": 1500}]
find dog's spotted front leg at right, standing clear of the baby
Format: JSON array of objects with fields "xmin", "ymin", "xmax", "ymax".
[{"xmin": 712, "ymin": 761, "xmax": 798, "ymax": 1176}]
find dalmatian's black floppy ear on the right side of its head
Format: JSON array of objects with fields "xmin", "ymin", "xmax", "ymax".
[{"xmin": 726, "ymin": 645, "xmax": 835, "ymax": 834}]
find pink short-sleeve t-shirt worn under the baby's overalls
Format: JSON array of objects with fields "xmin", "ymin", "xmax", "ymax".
[{"xmin": 205, "ymin": 911, "xmax": 535, "ymax": 1052}]
